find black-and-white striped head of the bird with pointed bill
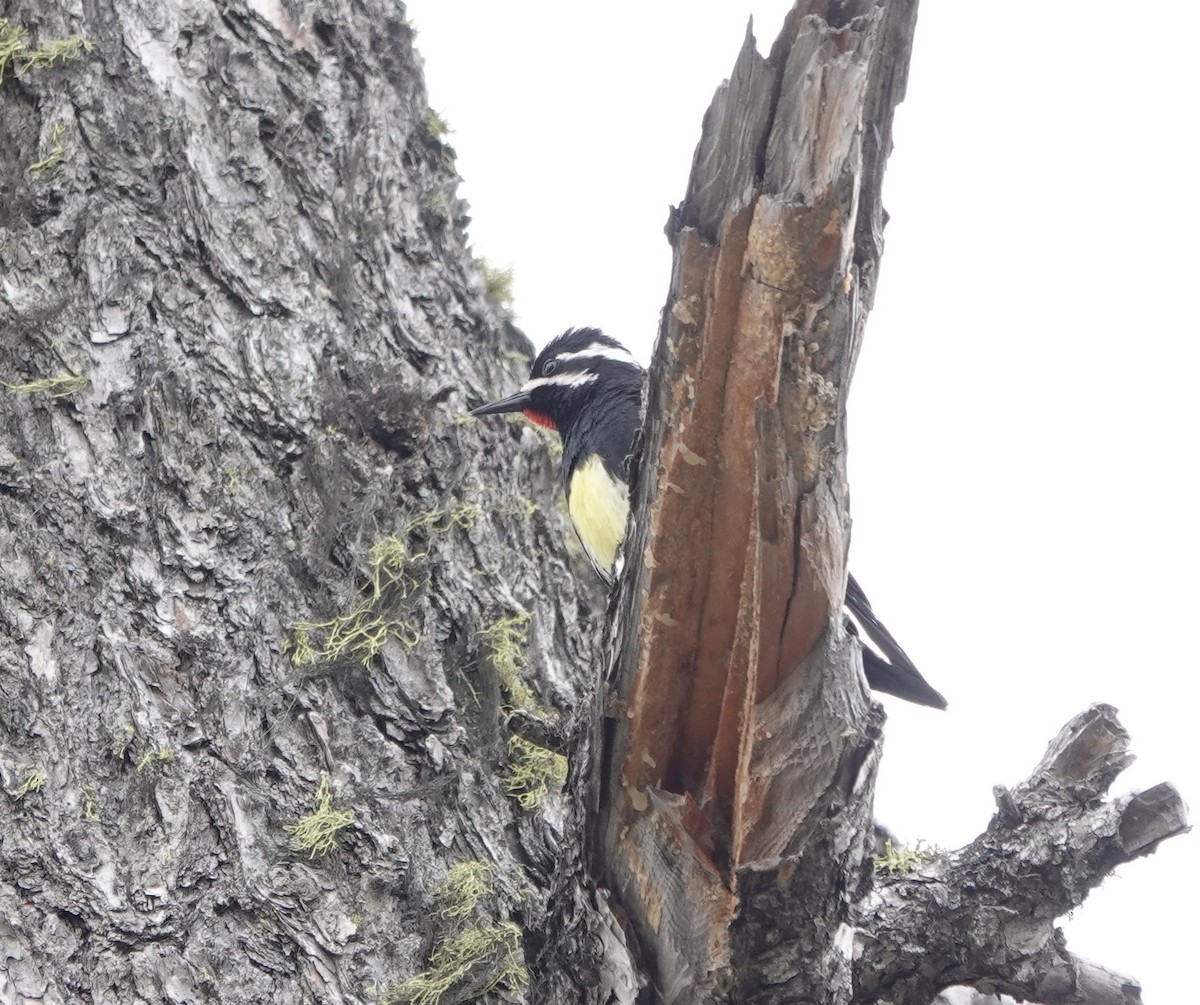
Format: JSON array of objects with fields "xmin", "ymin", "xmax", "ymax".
[{"xmin": 470, "ymin": 329, "xmax": 643, "ymax": 434}]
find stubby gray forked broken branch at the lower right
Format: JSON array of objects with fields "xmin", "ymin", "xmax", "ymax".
[{"xmin": 853, "ymin": 705, "xmax": 1188, "ymax": 1005}]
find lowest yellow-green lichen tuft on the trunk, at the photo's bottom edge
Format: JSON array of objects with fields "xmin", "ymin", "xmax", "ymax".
[{"xmin": 379, "ymin": 921, "xmax": 529, "ymax": 1005}]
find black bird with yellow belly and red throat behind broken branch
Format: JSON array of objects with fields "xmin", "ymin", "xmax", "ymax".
[{"xmin": 470, "ymin": 329, "xmax": 946, "ymax": 709}]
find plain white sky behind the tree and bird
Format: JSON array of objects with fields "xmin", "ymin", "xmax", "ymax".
[{"xmin": 408, "ymin": 0, "xmax": 1200, "ymax": 1003}]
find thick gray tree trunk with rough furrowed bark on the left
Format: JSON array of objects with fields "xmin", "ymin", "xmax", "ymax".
[{"xmin": 0, "ymin": 0, "xmax": 594, "ymax": 1005}]
